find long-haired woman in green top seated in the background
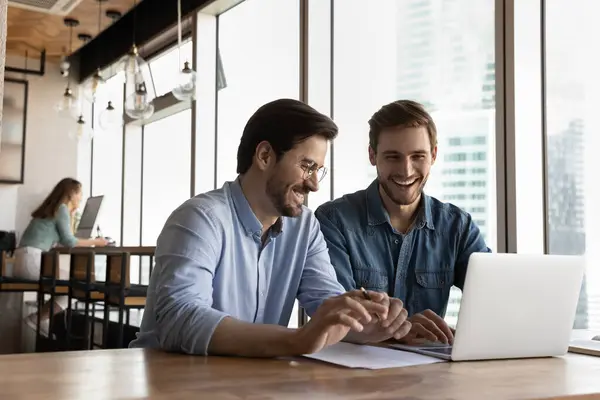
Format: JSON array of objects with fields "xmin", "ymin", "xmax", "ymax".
[{"xmin": 13, "ymin": 178, "xmax": 108, "ymax": 336}]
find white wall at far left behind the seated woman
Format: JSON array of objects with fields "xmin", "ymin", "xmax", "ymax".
[{"xmin": 0, "ymin": 59, "xmax": 84, "ymax": 235}]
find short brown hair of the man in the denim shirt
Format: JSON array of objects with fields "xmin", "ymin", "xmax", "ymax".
[{"xmin": 369, "ymin": 100, "xmax": 437, "ymax": 150}]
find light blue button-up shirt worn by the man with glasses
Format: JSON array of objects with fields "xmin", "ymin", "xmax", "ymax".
[{"xmin": 130, "ymin": 180, "xmax": 344, "ymax": 355}]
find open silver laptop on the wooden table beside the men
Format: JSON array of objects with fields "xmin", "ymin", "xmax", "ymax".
[{"xmin": 393, "ymin": 253, "xmax": 585, "ymax": 361}]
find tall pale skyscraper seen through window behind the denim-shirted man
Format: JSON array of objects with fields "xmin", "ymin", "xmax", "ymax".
[{"xmin": 396, "ymin": 0, "xmax": 496, "ymax": 325}]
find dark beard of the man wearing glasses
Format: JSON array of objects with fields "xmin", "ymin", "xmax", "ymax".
[{"xmin": 266, "ymin": 176, "xmax": 310, "ymax": 217}]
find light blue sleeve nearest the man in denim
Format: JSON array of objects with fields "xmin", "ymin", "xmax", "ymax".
[{"xmin": 298, "ymin": 212, "xmax": 345, "ymax": 315}]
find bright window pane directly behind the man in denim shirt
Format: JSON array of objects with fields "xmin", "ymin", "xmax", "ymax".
[{"xmin": 333, "ymin": 0, "xmax": 496, "ymax": 325}]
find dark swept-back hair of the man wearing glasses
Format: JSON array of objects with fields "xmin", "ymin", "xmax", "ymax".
[{"xmin": 237, "ymin": 99, "xmax": 338, "ymax": 174}]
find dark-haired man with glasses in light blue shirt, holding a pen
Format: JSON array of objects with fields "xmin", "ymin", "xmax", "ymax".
[{"xmin": 130, "ymin": 99, "xmax": 410, "ymax": 357}]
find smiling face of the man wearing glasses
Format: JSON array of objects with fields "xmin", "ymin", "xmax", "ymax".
[{"xmin": 259, "ymin": 135, "xmax": 327, "ymax": 217}]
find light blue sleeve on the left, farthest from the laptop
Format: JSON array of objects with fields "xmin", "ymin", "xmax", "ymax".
[{"xmin": 153, "ymin": 206, "xmax": 227, "ymax": 355}]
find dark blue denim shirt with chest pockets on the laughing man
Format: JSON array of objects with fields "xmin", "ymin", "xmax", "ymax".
[{"xmin": 315, "ymin": 180, "xmax": 491, "ymax": 316}]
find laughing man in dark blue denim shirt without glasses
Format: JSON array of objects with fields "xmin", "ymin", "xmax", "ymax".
[{"xmin": 315, "ymin": 100, "xmax": 490, "ymax": 343}]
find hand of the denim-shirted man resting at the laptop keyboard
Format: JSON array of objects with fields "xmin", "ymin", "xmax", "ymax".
[{"xmin": 401, "ymin": 310, "xmax": 454, "ymax": 344}]
